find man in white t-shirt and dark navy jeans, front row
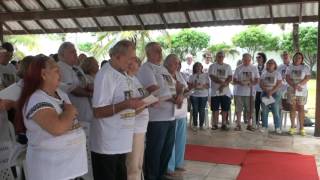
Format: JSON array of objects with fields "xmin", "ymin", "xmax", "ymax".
[{"xmin": 137, "ymin": 42, "xmax": 176, "ymax": 180}]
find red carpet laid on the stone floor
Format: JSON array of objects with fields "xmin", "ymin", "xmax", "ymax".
[{"xmin": 185, "ymin": 144, "xmax": 319, "ymax": 180}]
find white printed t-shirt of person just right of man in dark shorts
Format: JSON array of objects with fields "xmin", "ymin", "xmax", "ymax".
[{"xmin": 233, "ymin": 64, "xmax": 260, "ymax": 96}]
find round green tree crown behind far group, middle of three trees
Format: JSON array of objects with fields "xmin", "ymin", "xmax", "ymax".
[{"xmin": 232, "ymin": 26, "xmax": 279, "ymax": 59}]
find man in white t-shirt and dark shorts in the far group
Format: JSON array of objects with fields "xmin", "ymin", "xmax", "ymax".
[{"xmin": 209, "ymin": 51, "xmax": 232, "ymax": 130}]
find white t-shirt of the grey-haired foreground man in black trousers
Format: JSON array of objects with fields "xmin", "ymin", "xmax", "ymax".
[{"xmin": 90, "ymin": 64, "xmax": 135, "ymax": 154}]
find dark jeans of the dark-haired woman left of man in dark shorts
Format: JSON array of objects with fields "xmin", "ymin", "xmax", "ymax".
[{"xmin": 190, "ymin": 96, "xmax": 208, "ymax": 127}]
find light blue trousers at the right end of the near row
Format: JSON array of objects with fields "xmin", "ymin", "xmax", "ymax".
[{"xmin": 168, "ymin": 117, "xmax": 187, "ymax": 172}]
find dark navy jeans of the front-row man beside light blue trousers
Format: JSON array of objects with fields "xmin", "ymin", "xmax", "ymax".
[{"xmin": 144, "ymin": 120, "xmax": 176, "ymax": 180}]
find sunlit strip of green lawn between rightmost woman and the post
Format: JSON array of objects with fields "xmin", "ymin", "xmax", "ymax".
[{"xmin": 306, "ymin": 79, "xmax": 316, "ymax": 119}]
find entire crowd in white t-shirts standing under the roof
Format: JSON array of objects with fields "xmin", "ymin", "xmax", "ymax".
[{"xmin": 0, "ymin": 40, "xmax": 310, "ymax": 180}]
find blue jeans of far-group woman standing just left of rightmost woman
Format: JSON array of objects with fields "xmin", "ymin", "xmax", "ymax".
[{"xmin": 261, "ymin": 92, "xmax": 281, "ymax": 128}]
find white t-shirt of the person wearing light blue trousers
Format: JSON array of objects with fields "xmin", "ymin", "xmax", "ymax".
[{"xmin": 174, "ymin": 72, "xmax": 188, "ymax": 119}]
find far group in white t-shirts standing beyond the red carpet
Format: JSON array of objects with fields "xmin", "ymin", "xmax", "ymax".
[{"xmin": 182, "ymin": 51, "xmax": 311, "ymax": 136}]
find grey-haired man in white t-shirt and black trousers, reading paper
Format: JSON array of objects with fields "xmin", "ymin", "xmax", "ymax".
[{"xmin": 90, "ymin": 40, "xmax": 144, "ymax": 180}]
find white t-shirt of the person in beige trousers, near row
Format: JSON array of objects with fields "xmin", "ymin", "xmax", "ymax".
[{"xmin": 129, "ymin": 76, "xmax": 149, "ymax": 133}]
